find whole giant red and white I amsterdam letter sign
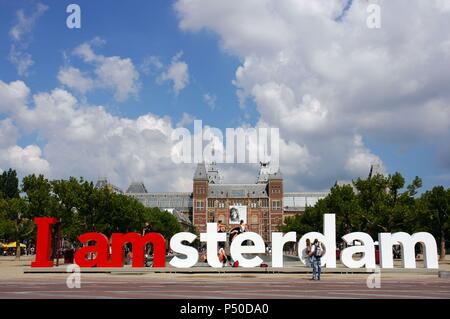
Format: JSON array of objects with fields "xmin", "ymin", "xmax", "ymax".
[{"xmin": 31, "ymin": 214, "xmax": 439, "ymax": 269}]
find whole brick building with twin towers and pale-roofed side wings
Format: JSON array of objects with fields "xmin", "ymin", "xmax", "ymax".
[{"xmin": 97, "ymin": 163, "xmax": 328, "ymax": 243}]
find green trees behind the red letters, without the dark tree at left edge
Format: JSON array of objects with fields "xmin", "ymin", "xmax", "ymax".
[{"xmin": 14, "ymin": 175, "xmax": 181, "ymax": 252}]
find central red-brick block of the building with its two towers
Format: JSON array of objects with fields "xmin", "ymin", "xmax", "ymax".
[{"xmin": 192, "ymin": 163, "xmax": 283, "ymax": 242}]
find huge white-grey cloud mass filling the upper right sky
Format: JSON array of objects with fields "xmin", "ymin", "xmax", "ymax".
[{"xmin": 175, "ymin": 0, "xmax": 450, "ymax": 189}]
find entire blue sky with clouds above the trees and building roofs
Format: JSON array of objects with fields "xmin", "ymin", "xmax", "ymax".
[{"xmin": 0, "ymin": 0, "xmax": 450, "ymax": 191}]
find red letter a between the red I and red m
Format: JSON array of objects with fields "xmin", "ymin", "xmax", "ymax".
[{"xmin": 74, "ymin": 233, "xmax": 110, "ymax": 268}]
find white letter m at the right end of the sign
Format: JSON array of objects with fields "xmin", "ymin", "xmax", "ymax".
[{"xmin": 378, "ymin": 232, "xmax": 439, "ymax": 269}]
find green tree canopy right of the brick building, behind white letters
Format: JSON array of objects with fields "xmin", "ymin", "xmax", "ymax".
[{"xmin": 281, "ymin": 172, "xmax": 450, "ymax": 258}]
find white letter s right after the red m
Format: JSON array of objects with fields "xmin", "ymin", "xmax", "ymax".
[{"xmin": 170, "ymin": 232, "xmax": 198, "ymax": 268}]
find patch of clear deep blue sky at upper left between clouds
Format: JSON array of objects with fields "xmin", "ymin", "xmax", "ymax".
[{"xmin": 0, "ymin": 0, "xmax": 246, "ymax": 127}]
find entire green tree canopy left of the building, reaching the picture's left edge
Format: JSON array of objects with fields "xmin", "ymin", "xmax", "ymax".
[{"xmin": 0, "ymin": 170, "xmax": 181, "ymax": 246}]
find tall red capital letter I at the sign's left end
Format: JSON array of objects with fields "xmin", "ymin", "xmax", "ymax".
[{"xmin": 31, "ymin": 217, "xmax": 56, "ymax": 268}]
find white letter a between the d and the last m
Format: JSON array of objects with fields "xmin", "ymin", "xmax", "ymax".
[{"xmin": 341, "ymin": 232, "xmax": 376, "ymax": 269}]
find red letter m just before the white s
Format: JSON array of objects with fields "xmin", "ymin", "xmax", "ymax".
[{"xmin": 110, "ymin": 233, "xmax": 166, "ymax": 268}]
